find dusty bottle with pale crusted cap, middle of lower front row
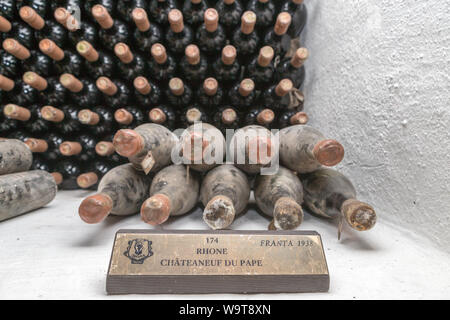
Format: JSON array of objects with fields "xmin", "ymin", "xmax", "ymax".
[{"xmin": 200, "ymin": 165, "xmax": 250, "ymax": 230}]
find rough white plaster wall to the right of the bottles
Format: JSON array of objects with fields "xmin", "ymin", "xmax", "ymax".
[{"xmin": 302, "ymin": 0, "xmax": 450, "ymax": 252}]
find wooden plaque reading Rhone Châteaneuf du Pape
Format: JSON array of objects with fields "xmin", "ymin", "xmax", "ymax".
[{"xmin": 106, "ymin": 230, "xmax": 330, "ymax": 294}]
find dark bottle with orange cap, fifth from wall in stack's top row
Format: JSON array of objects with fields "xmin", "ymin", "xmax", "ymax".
[{"xmin": 132, "ymin": 8, "xmax": 164, "ymax": 52}]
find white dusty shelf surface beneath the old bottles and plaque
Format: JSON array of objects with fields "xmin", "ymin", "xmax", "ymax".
[{"xmin": 0, "ymin": 191, "xmax": 450, "ymax": 300}]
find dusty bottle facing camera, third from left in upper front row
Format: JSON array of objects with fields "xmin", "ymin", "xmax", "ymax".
[{"xmin": 229, "ymin": 125, "xmax": 276, "ymax": 174}]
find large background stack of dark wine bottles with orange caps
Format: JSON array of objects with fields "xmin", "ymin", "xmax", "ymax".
[{"xmin": 0, "ymin": 0, "xmax": 308, "ymax": 189}]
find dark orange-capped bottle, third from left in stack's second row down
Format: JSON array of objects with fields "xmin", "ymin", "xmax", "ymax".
[{"xmin": 77, "ymin": 41, "xmax": 116, "ymax": 79}]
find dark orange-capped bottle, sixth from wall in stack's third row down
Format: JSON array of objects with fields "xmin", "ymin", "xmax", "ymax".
[{"xmin": 96, "ymin": 77, "xmax": 132, "ymax": 109}]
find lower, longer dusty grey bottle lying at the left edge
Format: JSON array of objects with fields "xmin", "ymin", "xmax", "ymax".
[{"xmin": 0, "ymin": 170, "xmax": 58, "ymax": 221}]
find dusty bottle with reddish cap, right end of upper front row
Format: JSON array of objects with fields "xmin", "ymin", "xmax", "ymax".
[{"xmin": 279, "ymin": 125, "xmax": 344, "ymax": 173}]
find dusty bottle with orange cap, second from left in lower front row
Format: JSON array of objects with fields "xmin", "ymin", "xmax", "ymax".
[{"xmin": 141, "ymin": 165, "xmax": 200, "ymax": 226}]
